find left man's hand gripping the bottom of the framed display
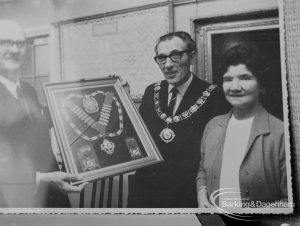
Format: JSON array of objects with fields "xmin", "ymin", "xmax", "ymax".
[{"xmin": 39, "ymin": 171, "xmax": 88, "ymax": 193}]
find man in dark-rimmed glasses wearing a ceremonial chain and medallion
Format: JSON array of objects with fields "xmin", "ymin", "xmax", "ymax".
[{"xmin": 128, "ymin": 31, "xmax": 228, "ymax": 208}]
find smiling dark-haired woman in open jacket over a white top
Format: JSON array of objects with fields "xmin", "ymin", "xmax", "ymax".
[{"xmin": 196, "ymin": 44, "xmax": 288, "ymax": 208}]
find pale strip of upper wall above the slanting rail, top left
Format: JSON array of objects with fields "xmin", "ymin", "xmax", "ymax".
[{"xmin": 0, "ymin": 0, "xmax": 164, "ymax": 28}]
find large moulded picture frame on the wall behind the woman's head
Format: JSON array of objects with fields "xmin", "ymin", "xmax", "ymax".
[{"xmin": 191, "ymin": 9, "xmax": 279, "ymax": 82}]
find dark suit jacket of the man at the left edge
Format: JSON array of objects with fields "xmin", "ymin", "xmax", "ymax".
[{"xmin": 0, "ymin": 83, "xmax": 70, "ymax": 207}]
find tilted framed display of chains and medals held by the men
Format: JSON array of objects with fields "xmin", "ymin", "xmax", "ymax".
[{"xmin": 43, "ymin": 76, "xmax": 163, "ymax": 181}]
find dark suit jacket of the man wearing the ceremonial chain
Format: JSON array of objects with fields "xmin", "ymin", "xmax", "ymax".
[{"xmin": 128, "ymin": 76, "xmax": 229, "ymax": 208}]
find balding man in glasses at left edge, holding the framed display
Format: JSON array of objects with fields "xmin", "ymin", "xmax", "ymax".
[{"xmin": 0, "ymin": 20, "xmax": 86, "ymax": 208}]
